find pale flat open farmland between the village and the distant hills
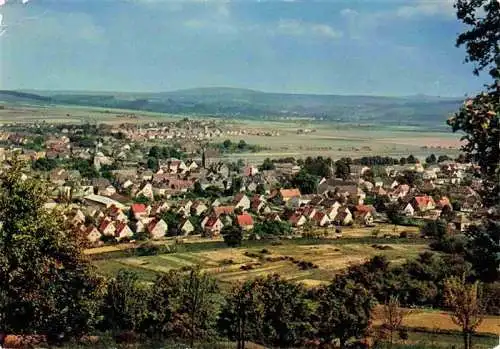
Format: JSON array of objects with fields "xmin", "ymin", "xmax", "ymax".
[{"xmin": 0, "ymin": 105, "xmax": 460, "ymax": 164}]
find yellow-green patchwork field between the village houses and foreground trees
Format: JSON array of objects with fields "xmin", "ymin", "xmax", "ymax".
[{"xmin": 94, "ymin": 238, "xmax": 427, "ymax": 286}]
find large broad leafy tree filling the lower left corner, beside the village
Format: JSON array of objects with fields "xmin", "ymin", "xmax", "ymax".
[{"xmin": 0, "ymin": 161, "xmax": 103, "ymax": 340}]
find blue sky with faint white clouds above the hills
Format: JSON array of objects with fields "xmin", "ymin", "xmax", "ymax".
[{"xmin": 0, "ymin": 0, "xmax": 492, "ymax": 97}]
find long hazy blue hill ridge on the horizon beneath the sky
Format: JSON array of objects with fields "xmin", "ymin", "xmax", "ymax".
[{"xmin": 0, "ymin": 87, "xmax": 462, "ymax": 126}]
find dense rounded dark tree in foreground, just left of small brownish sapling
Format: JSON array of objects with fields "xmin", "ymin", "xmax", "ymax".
[{"xmin": 316, "ymin": 276, "xmax": 374, "ymax": 348}]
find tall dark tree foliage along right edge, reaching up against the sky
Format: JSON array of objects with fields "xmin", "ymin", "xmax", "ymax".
[{"xmin": 448, "ymin": 0, "xmax": 500, "ymax": 286}]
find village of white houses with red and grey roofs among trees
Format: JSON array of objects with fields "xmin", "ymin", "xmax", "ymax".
[{"xmin": 0, "ymin": 120, "xmax": 481, "ymax": 246}]
